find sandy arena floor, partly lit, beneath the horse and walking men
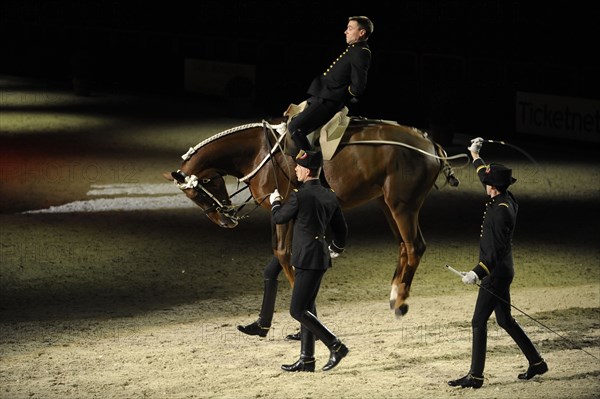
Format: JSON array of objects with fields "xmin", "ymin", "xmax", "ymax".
[{"xmin": 0, "ymin": 78, "xmax": 600, "ymax": 399}]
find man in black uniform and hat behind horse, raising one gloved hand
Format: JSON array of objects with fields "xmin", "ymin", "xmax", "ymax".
[{"xmin": 448, "ymin": 138, "xmax": 548, "ymax": 388}]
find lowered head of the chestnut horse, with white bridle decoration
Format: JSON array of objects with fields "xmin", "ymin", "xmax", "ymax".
[{"xmin": 171, "ymin": 170, "xmax": 238, "ymax": 228}]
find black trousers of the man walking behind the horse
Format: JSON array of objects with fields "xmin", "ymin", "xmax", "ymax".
[{"xmin": 470, "ymin": 277, "xmax": 542, "ymax": 376}]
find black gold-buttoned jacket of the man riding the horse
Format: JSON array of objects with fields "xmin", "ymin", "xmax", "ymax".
[{"xmin": 308, "ymin": 41, "xmax": 371, "ymax": 104}]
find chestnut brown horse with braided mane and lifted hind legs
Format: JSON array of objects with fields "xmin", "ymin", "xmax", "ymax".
[{"xmin": 165, "ymin": 117, "xmax": 458, "ymax": 317}]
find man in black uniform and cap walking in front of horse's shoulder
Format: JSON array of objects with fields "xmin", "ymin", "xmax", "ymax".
[{"xmin": 270, "ymin": 151, "xmax": 348, "ymax": 371}]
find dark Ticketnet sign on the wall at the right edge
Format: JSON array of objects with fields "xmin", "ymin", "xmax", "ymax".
[{"xmin": 516, "ymin": 92, "xmax": 600, "ymax": 142}]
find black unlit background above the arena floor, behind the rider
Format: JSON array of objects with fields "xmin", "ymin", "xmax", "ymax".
[{"xmin": 0, "ymin": 0, "xmax": 600, "ymax": 137}]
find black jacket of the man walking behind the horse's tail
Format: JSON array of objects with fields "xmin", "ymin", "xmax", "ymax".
[{"xmin": 473, "ymin": 158, "xmax": 519, "ymax": 281}]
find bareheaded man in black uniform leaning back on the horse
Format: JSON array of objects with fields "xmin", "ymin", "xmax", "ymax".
[{"xmin": 288, "ymin": 16, "xmax": 373, "ymax": 151}]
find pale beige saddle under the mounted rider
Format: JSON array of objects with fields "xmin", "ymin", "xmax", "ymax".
[{"xmin": 283, "ymin": 101, "xmax": 350, "ymax": 161}]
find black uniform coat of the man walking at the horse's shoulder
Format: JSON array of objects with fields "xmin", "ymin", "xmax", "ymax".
[{"xmin": 271, "ymin": 179, "xmax": 348, "ymax": 270}]
